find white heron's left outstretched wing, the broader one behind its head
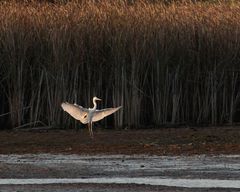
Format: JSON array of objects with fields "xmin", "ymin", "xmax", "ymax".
[{"xmin": 61, "ymin": 102, "xmax": 88, "ymax": 124}]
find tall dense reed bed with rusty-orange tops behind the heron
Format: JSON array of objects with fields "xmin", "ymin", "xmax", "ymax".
[{"xmin": 0, "ymin": 0, "xmax": 240, "ymax": 128}]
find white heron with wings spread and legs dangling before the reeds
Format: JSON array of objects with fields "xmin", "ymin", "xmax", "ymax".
[{"xmin": 61, "ymin": 97, "xmax": 122, "ymax": 138}]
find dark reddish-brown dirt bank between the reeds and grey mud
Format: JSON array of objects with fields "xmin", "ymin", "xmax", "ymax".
[{"xmin": 0, "ymin": 127, "xmax": 240, "ymax": 155}]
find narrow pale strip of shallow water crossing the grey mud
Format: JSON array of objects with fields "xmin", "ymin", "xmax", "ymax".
[{"xmin": 0, "ymin": 177, "xmax": 240, "ymax": 189}]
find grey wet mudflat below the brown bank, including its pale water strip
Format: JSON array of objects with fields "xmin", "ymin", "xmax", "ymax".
[{"xmin": 0, "ymin": 154, "xmax": 240, "ymax": 192}]
